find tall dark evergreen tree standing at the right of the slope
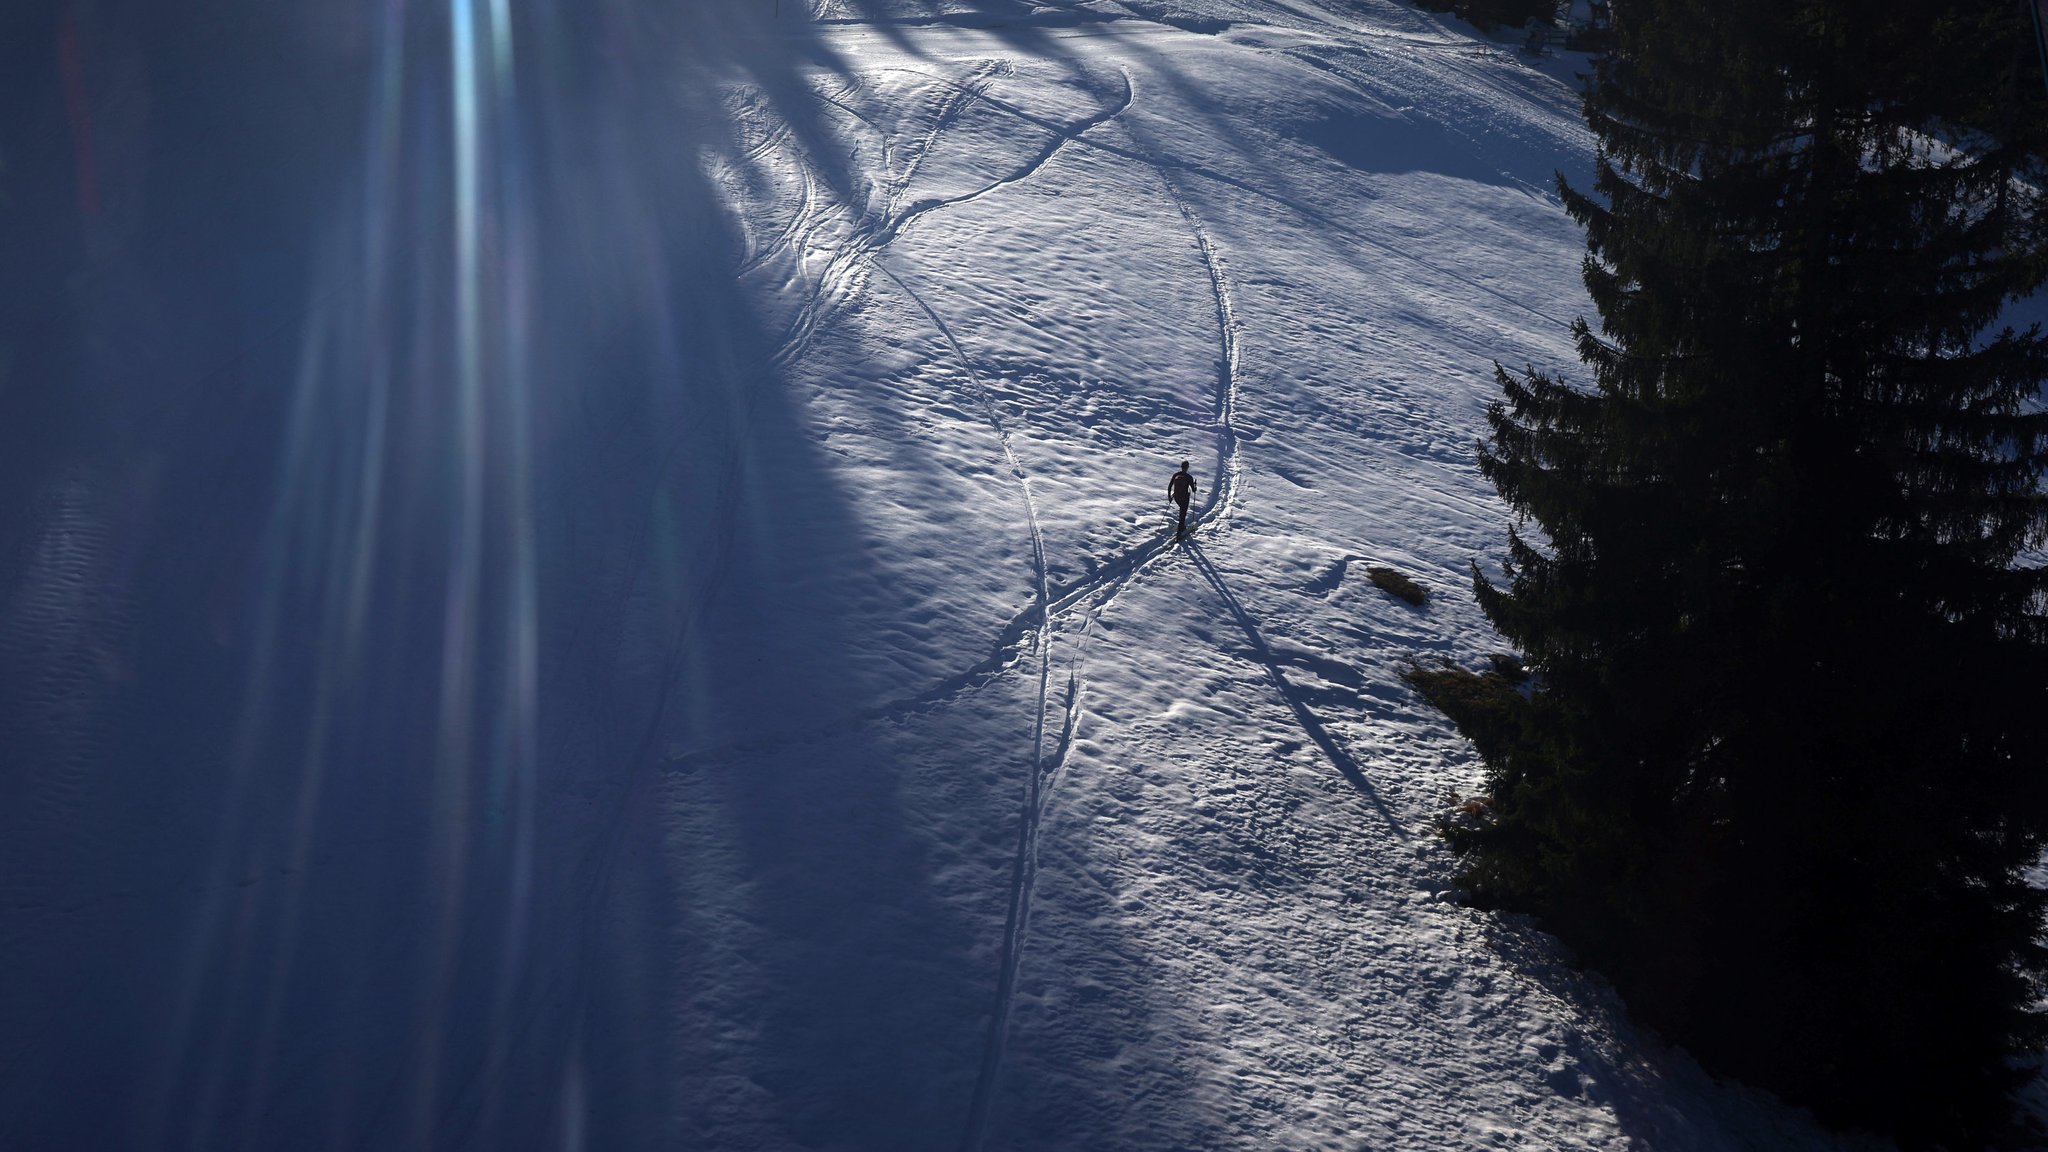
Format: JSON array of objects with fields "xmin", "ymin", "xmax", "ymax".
[{"xmin": 1411, "ymin": 0, "xmax": 2048, "ymax": 1148}]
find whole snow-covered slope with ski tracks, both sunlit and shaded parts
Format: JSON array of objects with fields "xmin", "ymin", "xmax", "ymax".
[{"xmin": 0, "ymin": 0, "xmax": 1884, "ymax": 1150}]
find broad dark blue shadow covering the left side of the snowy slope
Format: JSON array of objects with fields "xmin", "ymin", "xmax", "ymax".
[{"xmin": 0, "ymin": 0, "xmax": 995, "ymax": 1148}]
